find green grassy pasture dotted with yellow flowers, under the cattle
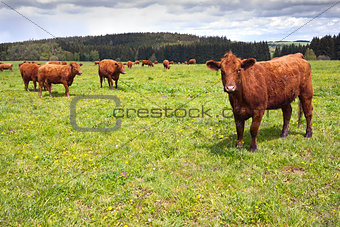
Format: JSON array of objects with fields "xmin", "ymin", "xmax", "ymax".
[{"xmin": 0, "ymin": 61, "xmax": 340, "ymax": 226}]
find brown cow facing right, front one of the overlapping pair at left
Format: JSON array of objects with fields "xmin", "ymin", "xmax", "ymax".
[{"xmin": 38, "ymin": 62, "xmax": 82, "ymax": 98}]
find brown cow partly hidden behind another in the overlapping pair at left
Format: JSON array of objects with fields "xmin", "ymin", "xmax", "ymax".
[{"xmin": 19, "ymin": 62, "xmax": 40, "ymax": 92}]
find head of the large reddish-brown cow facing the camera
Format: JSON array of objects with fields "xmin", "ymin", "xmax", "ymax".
[{"xmin": 206, "ymin": 51, "xmax": 256, "ymax": 93}]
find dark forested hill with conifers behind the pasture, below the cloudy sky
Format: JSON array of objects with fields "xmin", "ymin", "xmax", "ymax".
[{"xmin": 0, "ymin": 32, "xmax": 270, "ymax": 63}]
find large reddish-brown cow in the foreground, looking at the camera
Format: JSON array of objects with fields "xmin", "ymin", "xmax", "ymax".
[{"xmin": 206, "ymin": 51, "xmax": 313, "ymax": 152}]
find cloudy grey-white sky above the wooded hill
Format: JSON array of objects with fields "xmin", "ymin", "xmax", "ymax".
[{"xmin": 0, "ymin": 0, "xmax": 340, "ymax": 43}]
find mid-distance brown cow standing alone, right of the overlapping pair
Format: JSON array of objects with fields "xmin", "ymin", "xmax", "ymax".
[{"xmin": 98, "ymin": 59, "xmax": 126, "ymax": 90}]
